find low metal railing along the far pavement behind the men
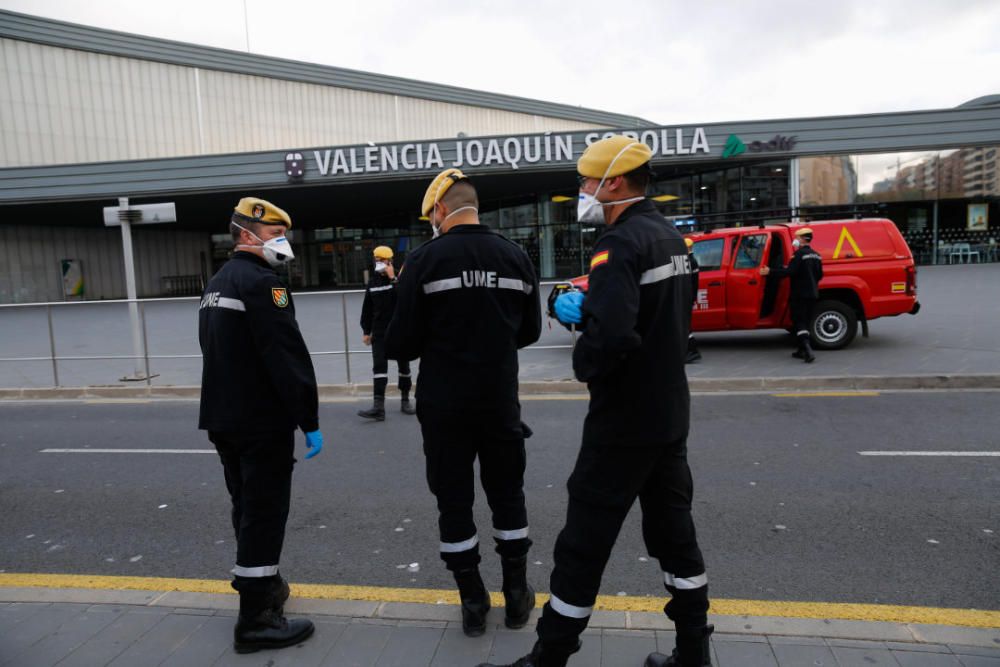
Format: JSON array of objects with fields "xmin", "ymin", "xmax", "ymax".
[{"xmin": 0, "ymin": 281, "xmax": 576, "ymax": 387}]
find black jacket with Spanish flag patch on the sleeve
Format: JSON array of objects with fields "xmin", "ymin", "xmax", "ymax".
[{"xmin": 573, "ymin": 200, "xmax": 692, "ymax": 447}]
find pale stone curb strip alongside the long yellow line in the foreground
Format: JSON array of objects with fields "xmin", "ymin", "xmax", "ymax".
[{"xmin": 0, "ymin": 584, "xmax": 1000, "ymax": 649}]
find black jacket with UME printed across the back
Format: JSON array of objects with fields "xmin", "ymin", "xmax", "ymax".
[{"xmin": 386, "ymin": 225, "xmax": 542, "ymax": 422}]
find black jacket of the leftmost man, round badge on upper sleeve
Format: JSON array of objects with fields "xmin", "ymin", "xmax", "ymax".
[{"xmin": 198, "ymin": 252, "xmax": 319, "ymax": 432}]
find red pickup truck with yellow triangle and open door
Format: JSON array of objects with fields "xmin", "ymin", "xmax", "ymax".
[{"xmin": 550, "ymin": 218, "xmax": 920, "ymax": 350}]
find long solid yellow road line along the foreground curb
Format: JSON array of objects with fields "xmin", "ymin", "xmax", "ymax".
[{"xmin": 0, "ymin": 573, "xmax": 1000, "ymax": 629}]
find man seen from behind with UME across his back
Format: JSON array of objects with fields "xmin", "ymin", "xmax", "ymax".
[{"xmin": 386, "ymin": 169, "xmax": 542, "ymax": 636}]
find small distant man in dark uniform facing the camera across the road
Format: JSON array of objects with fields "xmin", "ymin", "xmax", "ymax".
[{"xmin": 358, "ymin": 245, "xmax": 417, "ymax": 421}]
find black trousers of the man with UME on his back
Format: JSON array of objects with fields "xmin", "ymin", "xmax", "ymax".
[{"xmin": 417, "ymin": 401, "xmax": 531, "ymax": 572}]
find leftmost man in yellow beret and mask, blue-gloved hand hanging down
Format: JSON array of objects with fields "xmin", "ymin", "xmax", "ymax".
[{"xmin": 198, "ymin": 197, "xmax": 323, "ymax": 653}]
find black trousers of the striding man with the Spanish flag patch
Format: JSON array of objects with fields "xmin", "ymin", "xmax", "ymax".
[{"xmin": 538, "ymin": 439, "xmax": 708, "ymax": 653}]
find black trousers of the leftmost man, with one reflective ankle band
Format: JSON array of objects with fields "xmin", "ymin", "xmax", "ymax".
[{"xmin": 208, "ymin": 430, "xmax": 295, "ymax": 578}]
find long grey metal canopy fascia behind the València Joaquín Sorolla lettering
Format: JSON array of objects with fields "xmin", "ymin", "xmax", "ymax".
[{"xmin": 0, "ymin": 98, "xmax": 1000, "ymax": 205}]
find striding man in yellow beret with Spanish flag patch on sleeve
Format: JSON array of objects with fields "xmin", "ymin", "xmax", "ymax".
[{"xmin": 481, "ymin": 135, "xmax": 713, "ymax": 667}]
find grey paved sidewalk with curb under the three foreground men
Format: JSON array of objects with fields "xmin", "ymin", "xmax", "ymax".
[{"xmin": 0, "ymin": 587, "xmax": 1000, "ymax": 667}]
